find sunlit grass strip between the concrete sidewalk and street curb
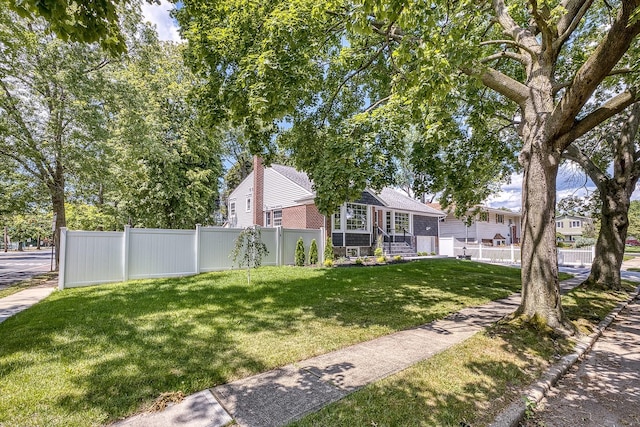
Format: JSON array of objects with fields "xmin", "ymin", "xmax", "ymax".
[{"xmin": 290, "ymin": 284, "xmax": 632, "ymax": 427}]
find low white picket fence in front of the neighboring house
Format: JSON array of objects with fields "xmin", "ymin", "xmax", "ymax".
[{"xmin": 440, "ymin": 237, "xmax": 595, "ymax": 266}]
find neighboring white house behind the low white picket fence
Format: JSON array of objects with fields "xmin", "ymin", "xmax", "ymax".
[{"xmin": 429, "ymin": 203, "xmax": 522, "ymax": 246}]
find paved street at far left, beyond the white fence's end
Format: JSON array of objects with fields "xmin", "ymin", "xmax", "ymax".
[{"xmin": 0, "ymin": 252, "xmax": 51, "ymax": 289}]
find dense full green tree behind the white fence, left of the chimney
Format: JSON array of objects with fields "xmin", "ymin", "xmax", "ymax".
[{"xmin": 105, "ymin": 28, "xmax": 222, "ymax": 228}]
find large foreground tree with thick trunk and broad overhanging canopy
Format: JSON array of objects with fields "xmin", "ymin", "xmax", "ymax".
[{"xmin": 176, "ymin": 0, "xmax": 640, "ymax": 331}]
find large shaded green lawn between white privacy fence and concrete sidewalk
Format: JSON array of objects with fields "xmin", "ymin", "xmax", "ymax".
[{"xmin": 0, "ymin": 259, "xmax": 552, "ymax": 426}]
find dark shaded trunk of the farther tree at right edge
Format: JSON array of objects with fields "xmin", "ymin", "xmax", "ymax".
[{"xmin": 585, "ymin": 183, "xmax": 631, "ymax": 289}]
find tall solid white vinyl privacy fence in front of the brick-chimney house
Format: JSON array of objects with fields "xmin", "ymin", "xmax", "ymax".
[{"xmin": 58, "ymin": 226, "xmax": 325, "ymax": 289}]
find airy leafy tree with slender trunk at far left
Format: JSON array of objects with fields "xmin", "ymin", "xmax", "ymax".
[{"xmin": 0, "ymin": 8, "xmax": 117, "ymax": 260}]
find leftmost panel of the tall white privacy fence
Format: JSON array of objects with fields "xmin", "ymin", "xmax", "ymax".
[{"xmin": 60, "ymin": 230, "xmax": 124, "ymax": 288}]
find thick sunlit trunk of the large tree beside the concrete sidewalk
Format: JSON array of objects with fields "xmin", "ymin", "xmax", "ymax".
[{"xmin": 516, "ymin": 141, "xmax": 572, "ymax": 331}]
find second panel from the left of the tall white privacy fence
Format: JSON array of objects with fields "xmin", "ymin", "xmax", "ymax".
[{"xmin": 128, "ymin": 228, "xmax": 197, "ymax": 279}]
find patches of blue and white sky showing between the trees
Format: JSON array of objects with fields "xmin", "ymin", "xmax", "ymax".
[{"xmin": 142, "ymin": 0, "xmax": 640, "ymax": 210}]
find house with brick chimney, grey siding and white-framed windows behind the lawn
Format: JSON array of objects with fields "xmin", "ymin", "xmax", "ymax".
[{"xmin": 228, "ymin": 157, "xmax": 445, "ymax": 256}]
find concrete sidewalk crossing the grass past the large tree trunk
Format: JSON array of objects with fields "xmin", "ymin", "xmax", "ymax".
[{"xmin": 116, "ymin": 276, "xmax": 585, "ymax": 427}]
